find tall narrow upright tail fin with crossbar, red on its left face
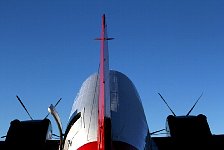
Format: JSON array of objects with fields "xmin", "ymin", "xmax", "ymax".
[{"xmin": 96, "ymin": 14, "xmax": 113, "ymax": 150}]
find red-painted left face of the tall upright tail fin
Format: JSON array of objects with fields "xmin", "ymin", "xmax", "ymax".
[{"xmin": 97, "ymin": 15, "xmax": 105, "ymax": 150}]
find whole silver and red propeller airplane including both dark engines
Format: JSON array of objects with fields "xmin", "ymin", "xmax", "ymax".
[{"xmin": 0, "ymin": 14, "xmax": 224, "ymax": 150}]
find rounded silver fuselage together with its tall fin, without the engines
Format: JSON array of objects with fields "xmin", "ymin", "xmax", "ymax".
[{"xmin": 64, "ymin": 15, "xmax": 150, "ymax": 150}]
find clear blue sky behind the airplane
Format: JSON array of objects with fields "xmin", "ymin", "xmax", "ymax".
[{"xmin": 0, "ymin": 0, "xmax": 224, "ymax": 136}]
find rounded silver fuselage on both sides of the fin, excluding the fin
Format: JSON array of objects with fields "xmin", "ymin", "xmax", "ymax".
[{"xmin": 64, "ymin": 71, "xmax": 150, "ymax": 150}]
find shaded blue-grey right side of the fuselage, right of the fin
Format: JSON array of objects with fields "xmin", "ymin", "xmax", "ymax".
[{"xmin": 110, "ymin": 71, "xmax": 149, "ymax": 150}]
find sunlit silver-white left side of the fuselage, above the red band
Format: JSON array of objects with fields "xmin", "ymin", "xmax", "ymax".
[{"xmin": 64, "ymin": 74, "xmax": 99, "ymax": 150}]
